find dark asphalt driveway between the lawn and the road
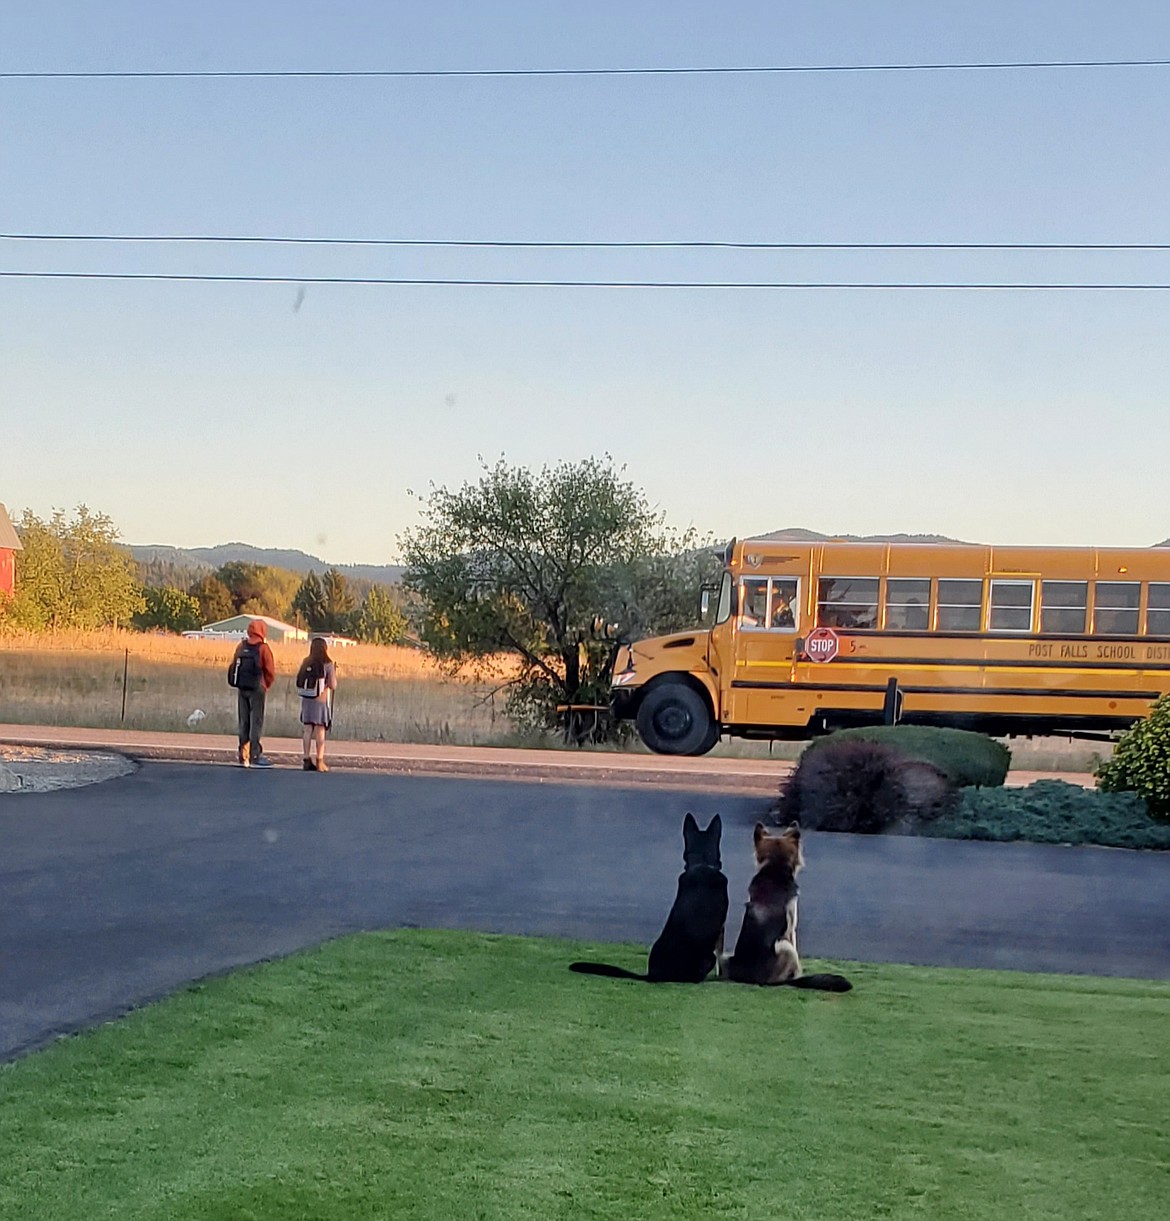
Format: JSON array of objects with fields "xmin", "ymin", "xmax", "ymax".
[{"xmin": 0, "ymin": 763, "xmax": 1170, "ymax": 1059}]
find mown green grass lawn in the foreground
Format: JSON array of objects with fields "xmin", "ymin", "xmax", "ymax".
[{"xmin": 0, "ymin": 932, "xmax": 1170, "ymax": 1221}]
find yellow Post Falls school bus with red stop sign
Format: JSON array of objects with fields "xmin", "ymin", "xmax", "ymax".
[{"xmin": 613, "ymin": 538, "xmax": 1170, "ymax": 755}]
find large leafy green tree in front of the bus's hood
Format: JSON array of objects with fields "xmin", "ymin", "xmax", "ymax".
[{"xmin": 402, "ymin": 457, "xmax": 713, "ymax": 728}]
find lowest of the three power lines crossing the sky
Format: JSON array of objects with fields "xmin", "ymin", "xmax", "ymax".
[{"xmin": 0, "ymin": 271, "xmax": 1170, "ymax": 292}]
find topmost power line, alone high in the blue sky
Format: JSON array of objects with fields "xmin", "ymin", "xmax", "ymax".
[{"xmin": 0, "ymin": 60, "xmax": 1170, "ymax": 81}]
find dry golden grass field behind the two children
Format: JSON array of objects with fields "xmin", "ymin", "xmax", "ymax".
[{"xmin": 0, "ymin": 631, "xmax": 1111, "ymax": 772}]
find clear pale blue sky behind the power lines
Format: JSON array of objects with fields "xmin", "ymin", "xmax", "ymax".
[{"xmin": 0, "ymin": 0, "xmax": 1170, "ymax": 563}]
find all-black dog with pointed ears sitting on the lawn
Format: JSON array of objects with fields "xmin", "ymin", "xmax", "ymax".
[{"xmin": 569, "ymin": 814, "xmax": 727, "ymax": 984}]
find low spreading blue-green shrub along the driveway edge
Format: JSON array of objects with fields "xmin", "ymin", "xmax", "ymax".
[{"xmin": 921, "ymin": 780, "xmax": 1170, "ymax": 849}]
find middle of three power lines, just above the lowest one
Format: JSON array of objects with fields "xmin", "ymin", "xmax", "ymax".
[{"xmin": 0, "ymin": 233, "xmax": 1170, "ymax": 252}]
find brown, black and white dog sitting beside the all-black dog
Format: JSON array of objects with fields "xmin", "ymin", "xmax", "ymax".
[{"xmin": 719, "ymin": 823, "xmax": 852, "ymax": 991}]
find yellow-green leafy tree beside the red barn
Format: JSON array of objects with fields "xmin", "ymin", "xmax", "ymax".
[{"xmin": 7, "ymin": 504, "xmax": 143, "ymax": 631}]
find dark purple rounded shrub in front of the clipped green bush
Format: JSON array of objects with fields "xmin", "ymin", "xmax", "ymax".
[{"xmin": 776, "ymin": 735, "xmax": 955, "ymax": 835}]
